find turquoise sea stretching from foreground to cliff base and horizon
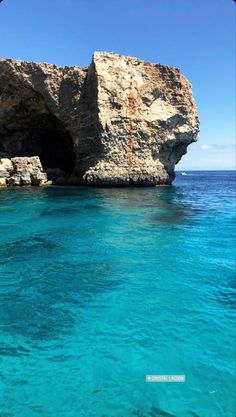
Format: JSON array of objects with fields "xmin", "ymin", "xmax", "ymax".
[{"xmin": 0, "ymin": 172, "xmax": 235, "ymax": 417}]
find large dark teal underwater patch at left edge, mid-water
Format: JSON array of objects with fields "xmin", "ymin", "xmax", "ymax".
[{"xmin": 0, "ymin": 255, "xmax": 126, "ymax": 341}]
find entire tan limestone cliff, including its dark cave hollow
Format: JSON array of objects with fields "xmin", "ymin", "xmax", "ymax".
[{"xmin": 0, "ymin": 52, "xmax": 199, "ymax": 185}]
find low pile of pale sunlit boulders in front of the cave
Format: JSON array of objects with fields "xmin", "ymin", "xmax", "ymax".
[{"xmin": 0, "ymin": 156, "xmax": 51, "ymax": 186}]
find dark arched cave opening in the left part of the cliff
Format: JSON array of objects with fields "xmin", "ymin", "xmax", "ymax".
[{"xmin": 0, "ymin": 84, "xmax": 76, "ymax": 174}]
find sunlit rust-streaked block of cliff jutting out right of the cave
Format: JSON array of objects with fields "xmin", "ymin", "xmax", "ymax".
[{"xmin": 79, "ymin": 53, "xmax": 198, "ymax": 185}]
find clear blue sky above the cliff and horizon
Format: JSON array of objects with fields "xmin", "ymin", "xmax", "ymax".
[{"xmin": 0, "ymin": 0, "xmax": 235, "ymax": 170}]
